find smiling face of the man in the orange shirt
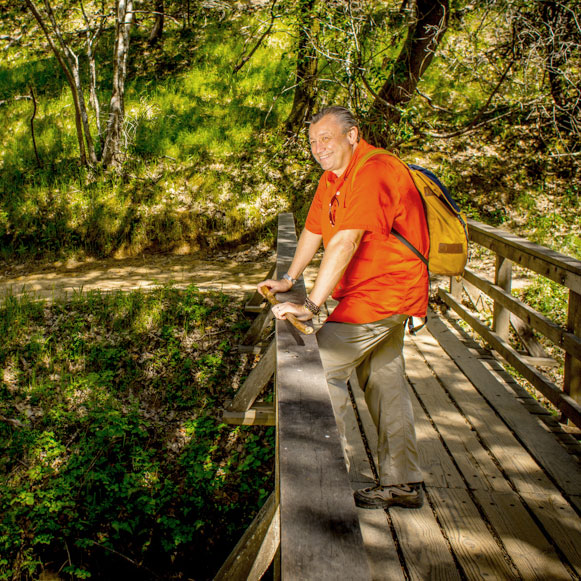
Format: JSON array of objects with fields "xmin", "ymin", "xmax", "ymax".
[{"xmin": 309, "ymin": 115, "xmax": 357, "ymax": 176}]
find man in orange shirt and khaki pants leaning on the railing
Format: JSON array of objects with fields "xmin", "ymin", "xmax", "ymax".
[{"xmin": 258, "ymin": 107, "xmax": 429, "ymax": 508}]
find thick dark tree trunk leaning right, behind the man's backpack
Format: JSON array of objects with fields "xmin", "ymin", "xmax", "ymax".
[{"xmin": 365, "ymin": 0, "xmax": 449, "ymax": 145}]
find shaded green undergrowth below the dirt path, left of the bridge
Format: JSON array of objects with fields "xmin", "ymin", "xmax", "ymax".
[{"xmin": 0, "ymin": 286, "xmax": 274, "ymax": 579}]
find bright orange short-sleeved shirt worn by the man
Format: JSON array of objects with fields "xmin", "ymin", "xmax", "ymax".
[{"xmin": 305, "ymin": 140, "xmax": 429, "ymax": 324}]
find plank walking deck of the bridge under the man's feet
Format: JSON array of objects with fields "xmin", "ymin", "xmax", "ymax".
[{"xmin": 340, "ymin": 314, "xmax": 581, "ymax": 581}]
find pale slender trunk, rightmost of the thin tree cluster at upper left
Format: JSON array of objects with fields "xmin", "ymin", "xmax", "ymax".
[{"xmin": 102, "ymin": 0, "xmax": 133, "ymax": 167}]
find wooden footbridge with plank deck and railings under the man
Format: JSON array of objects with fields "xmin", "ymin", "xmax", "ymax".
[{"xmin": 216, "ymin": 214, "xmax": 581, "ymax": 581}]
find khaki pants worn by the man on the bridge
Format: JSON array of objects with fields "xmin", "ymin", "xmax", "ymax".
[{"xmin": 317, "ymin": 315, "xmax": 423, "ymax": 486}]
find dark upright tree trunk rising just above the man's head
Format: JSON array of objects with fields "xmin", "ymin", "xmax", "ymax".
[{"xmin": 285, "ymin": 0, "xmax": 319, "ymax": 133}]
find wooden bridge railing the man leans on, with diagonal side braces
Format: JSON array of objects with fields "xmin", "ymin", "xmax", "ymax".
[{"xmin": 215, "ymin": 214, "xmax": 370, "ymax": 581}]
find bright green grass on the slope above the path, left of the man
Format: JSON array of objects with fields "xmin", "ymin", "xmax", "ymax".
[{"xmin": 0, "ymin": 11, "xmax": 304, "ymax": 260}]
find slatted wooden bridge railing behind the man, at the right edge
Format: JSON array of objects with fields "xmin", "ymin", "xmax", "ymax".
[{"xmin": 438, "ymin": 220, "xmax": 581, "ymax": 427}]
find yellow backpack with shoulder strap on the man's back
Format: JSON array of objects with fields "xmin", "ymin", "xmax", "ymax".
[{"xmin": 351, "ymin": 149, "xmax": 468, "ymax": 276}]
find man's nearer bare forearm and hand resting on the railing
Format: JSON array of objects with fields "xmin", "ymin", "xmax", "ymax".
[{"xmin": 265, "ymin": 230, "xmax": 365, "ymax": 321}]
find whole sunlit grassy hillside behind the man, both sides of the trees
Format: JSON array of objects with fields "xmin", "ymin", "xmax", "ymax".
[{"xmin": 0, "ymin": 3, "xmax": 581, "ymax": 260}]
